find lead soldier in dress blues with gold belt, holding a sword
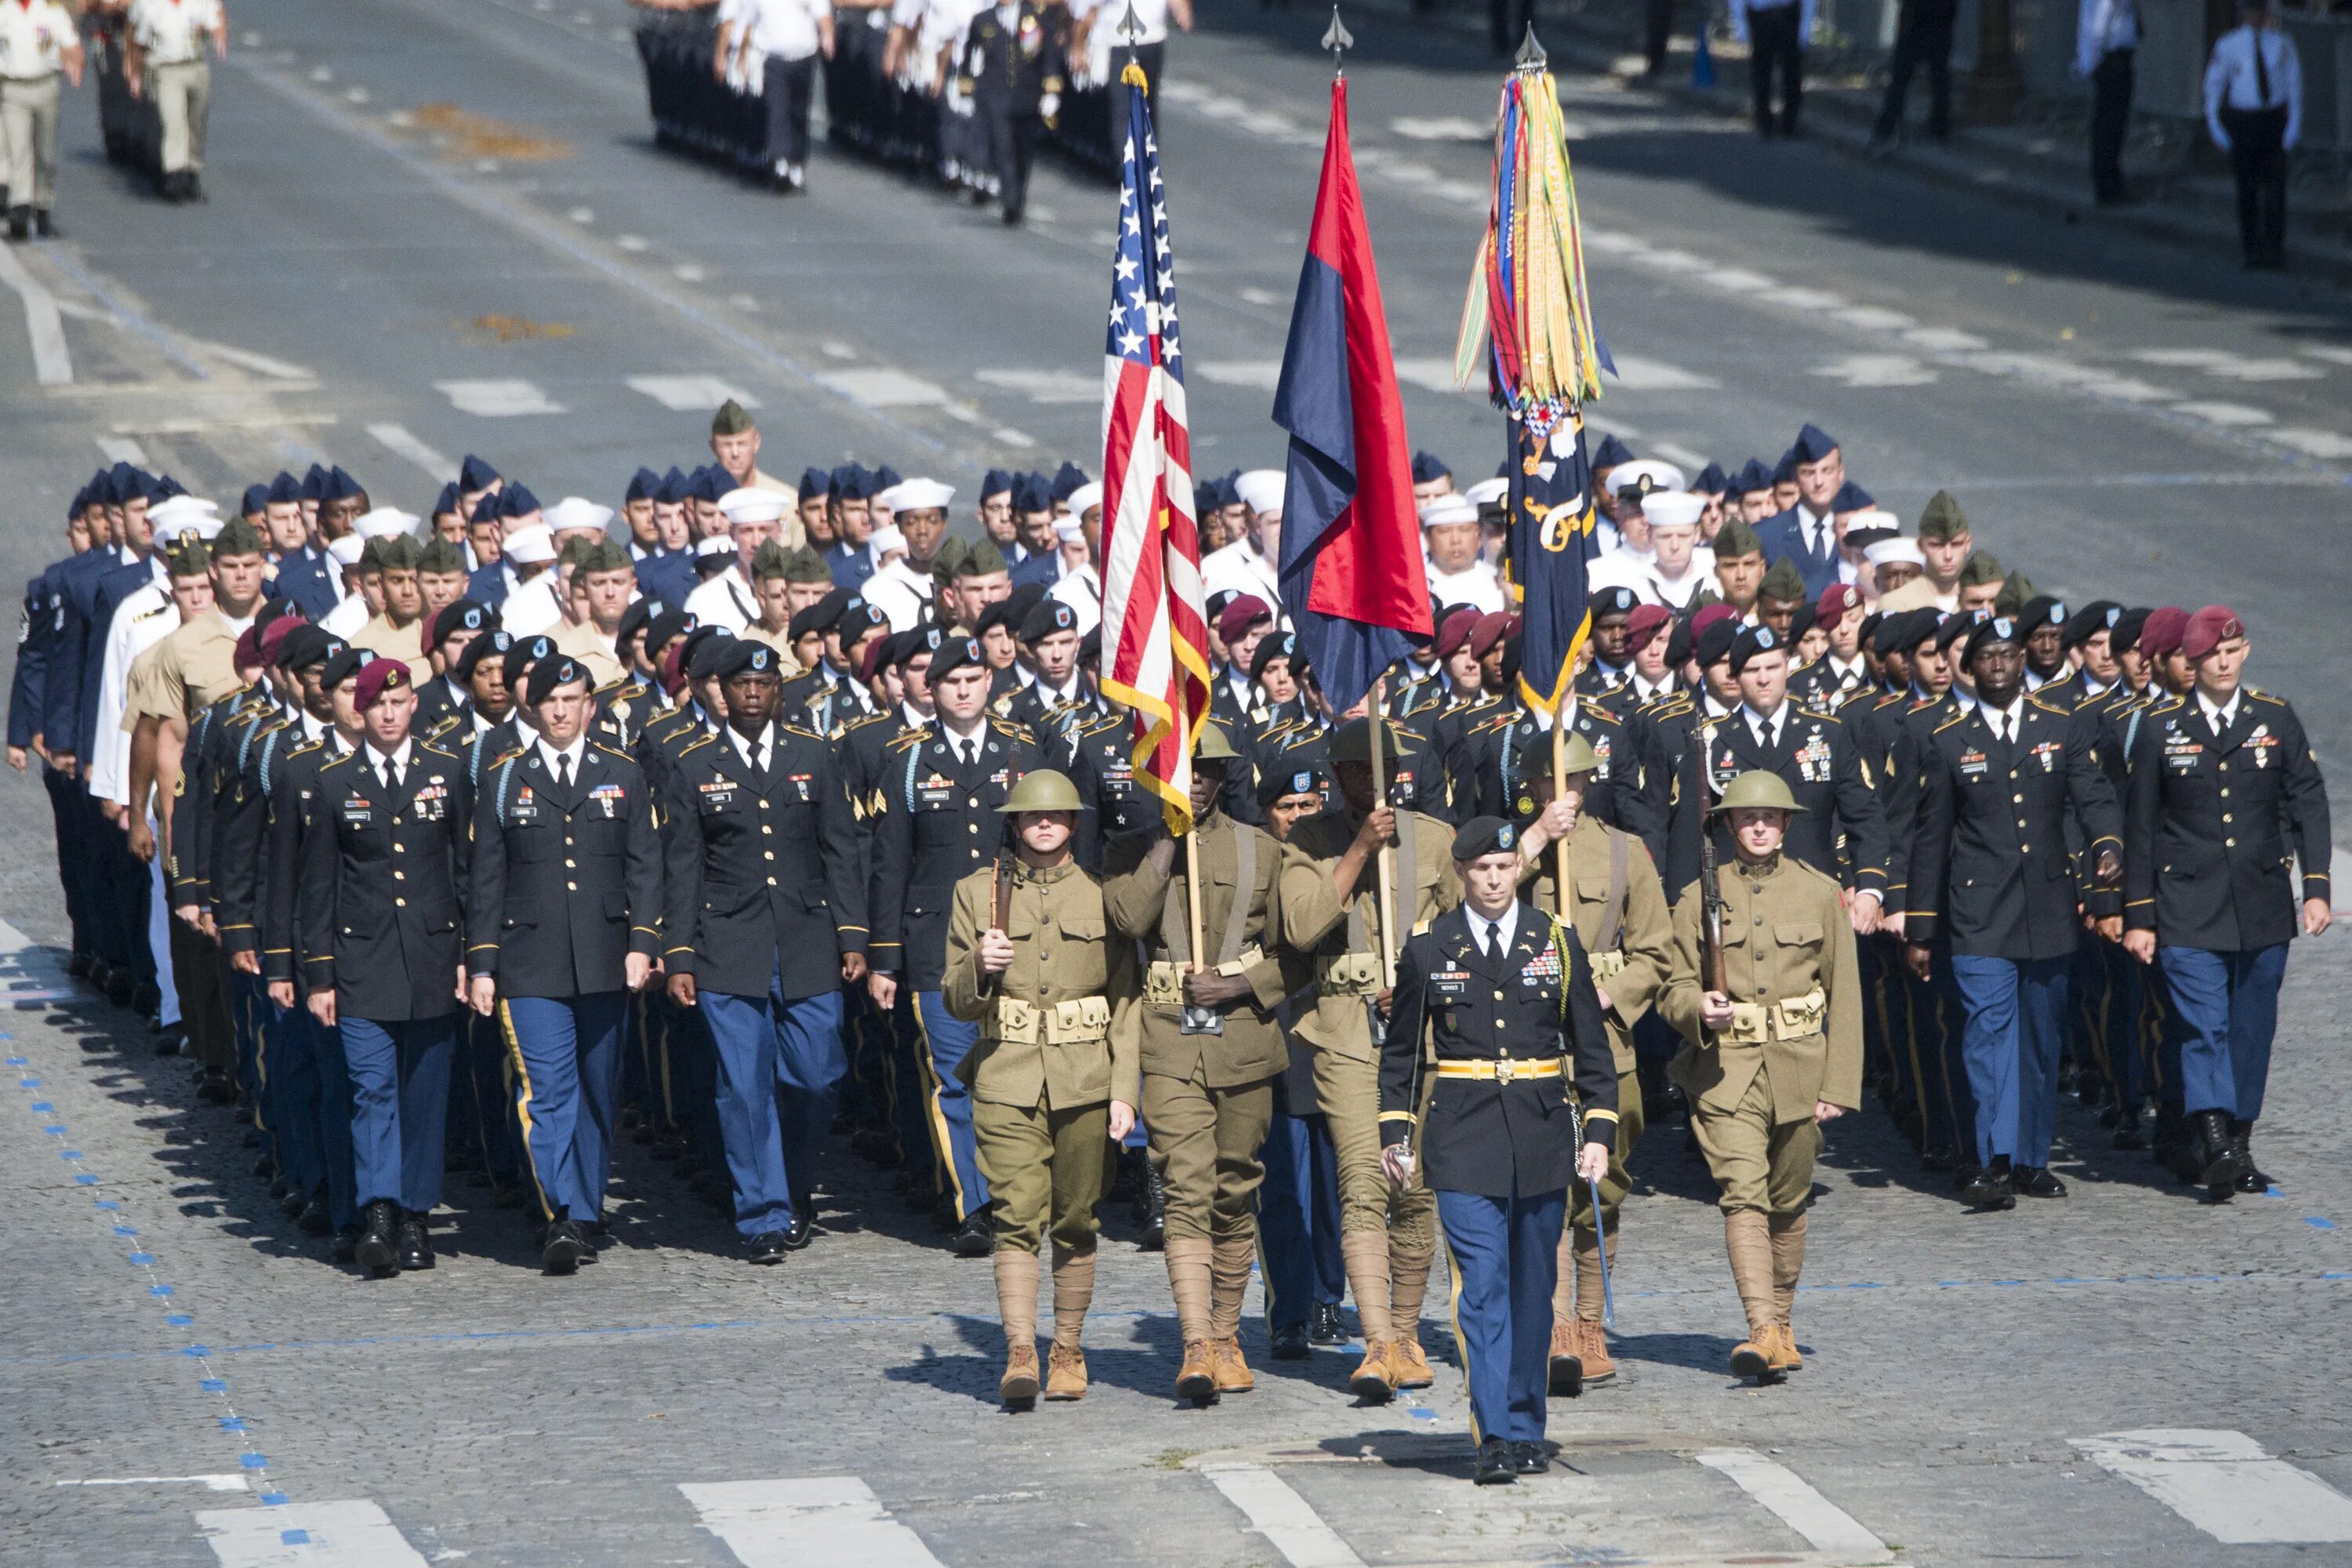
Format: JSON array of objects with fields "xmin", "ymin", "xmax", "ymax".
[{"xmin": 1381, "ymin": 815, "xmax": 1616, "ymax": 1486}]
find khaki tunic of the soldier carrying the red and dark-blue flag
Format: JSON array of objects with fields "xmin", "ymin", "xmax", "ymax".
[{"xmin": 1282, "ymin": 811, "xmax": 1463, "ymax": 1062}]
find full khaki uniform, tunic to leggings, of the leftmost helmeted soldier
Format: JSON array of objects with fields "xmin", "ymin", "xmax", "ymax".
[{"xmin": 941, "ymin": 860, "xmax": 1141, "ymax": 1382}]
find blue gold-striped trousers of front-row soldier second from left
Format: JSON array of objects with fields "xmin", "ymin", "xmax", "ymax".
[{"xmin": 499, "ymin": 992, "xmax": 628, "ymax": 1225}]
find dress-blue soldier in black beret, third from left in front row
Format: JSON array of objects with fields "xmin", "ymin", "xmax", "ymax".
[{"xmin": 663, "ymin": 637, "xmax": 866, "ymax": 1262}]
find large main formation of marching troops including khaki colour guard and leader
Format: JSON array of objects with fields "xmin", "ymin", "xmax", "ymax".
[{"xmin": 9, "ymin": 405, "xmax": 2331, "ymax": 1481}]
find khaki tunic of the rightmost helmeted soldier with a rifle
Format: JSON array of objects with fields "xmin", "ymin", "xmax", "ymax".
[{"xmin": 1665, "ymin": 855, "xmax": 1863, "ymax": 1123}]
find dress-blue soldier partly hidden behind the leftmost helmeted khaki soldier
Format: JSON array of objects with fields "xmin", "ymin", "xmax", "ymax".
[{"xmin": 868, "ymin": 637, "xmax": 1044, "ymax": 1258}]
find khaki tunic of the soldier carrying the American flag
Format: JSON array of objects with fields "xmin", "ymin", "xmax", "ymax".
[{"xmin": 1103, "ymin": 811, "xmax": 1291, "ymax": 1088}]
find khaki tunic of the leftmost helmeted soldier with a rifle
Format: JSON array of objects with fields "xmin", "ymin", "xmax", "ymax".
[{"xmin": 941, "ymin": 862, "xmax": 1143, "ymax": 1109}]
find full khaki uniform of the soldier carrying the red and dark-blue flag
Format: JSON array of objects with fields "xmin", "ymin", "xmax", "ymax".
[{"xmin": 1282, "ymin": 811, "xmax": 1463, "ymax": 1382}]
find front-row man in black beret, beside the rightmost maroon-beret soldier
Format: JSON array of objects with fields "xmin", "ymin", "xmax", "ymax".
[{"xmin": 1903, "ymin": 616, "xmax": 2124, "ymax": 1208}]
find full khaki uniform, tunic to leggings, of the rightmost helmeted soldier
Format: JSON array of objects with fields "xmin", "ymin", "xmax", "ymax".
[{"xmin": 1658, "ymin": 853, "xmax": 1863, "ymax": 1356}]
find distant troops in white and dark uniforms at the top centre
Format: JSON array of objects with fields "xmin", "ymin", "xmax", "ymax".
[{"xmin": 633, "ymin": 0, "xmax": 1192, "ymax": 223}]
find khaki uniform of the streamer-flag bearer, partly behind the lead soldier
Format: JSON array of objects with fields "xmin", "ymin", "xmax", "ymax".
[{"xmin": 1526, "ymin": 815, "xmax": 1675, "ymax": 1354}]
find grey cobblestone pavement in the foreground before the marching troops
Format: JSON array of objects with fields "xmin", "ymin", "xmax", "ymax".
[{"xmin": 0, "ymin": 902, "xmax": 2352, "ymax": 1568}]
